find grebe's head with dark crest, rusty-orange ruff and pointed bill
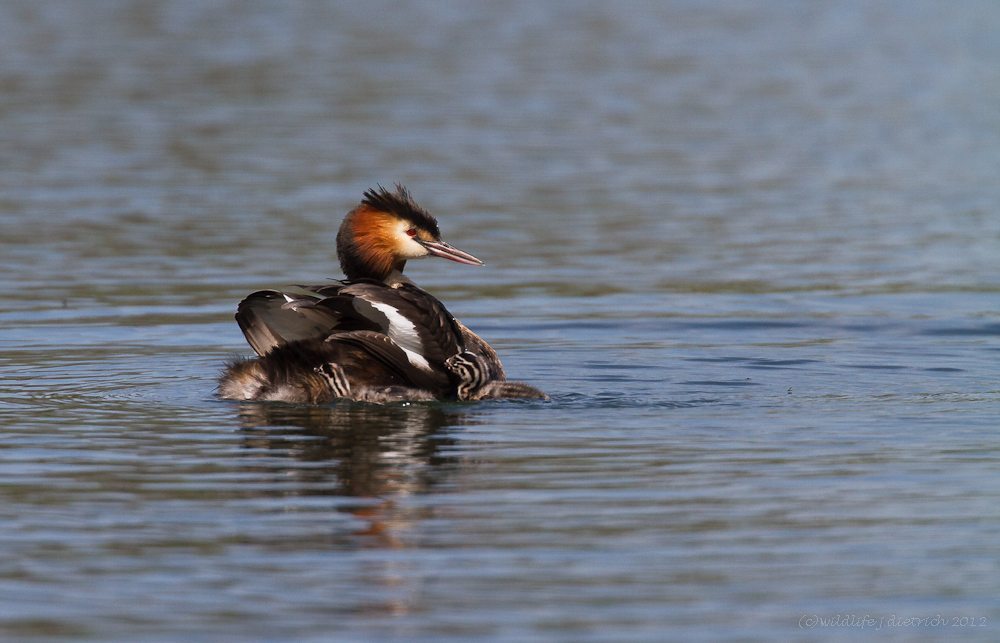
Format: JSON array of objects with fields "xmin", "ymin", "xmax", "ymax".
[{"xmin": 337, "ymin": 185, "xmax": 483, "ymax": 281}]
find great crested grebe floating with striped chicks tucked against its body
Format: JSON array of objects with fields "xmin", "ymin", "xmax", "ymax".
[{"xmin": 218, "ymin": 185, "xmax": 548, "ymax": 404}]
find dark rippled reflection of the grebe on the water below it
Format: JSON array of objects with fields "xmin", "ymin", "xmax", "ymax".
[{"xmin": 240, "ymin": 404, "xmax": 470, "ymax": 548}]
